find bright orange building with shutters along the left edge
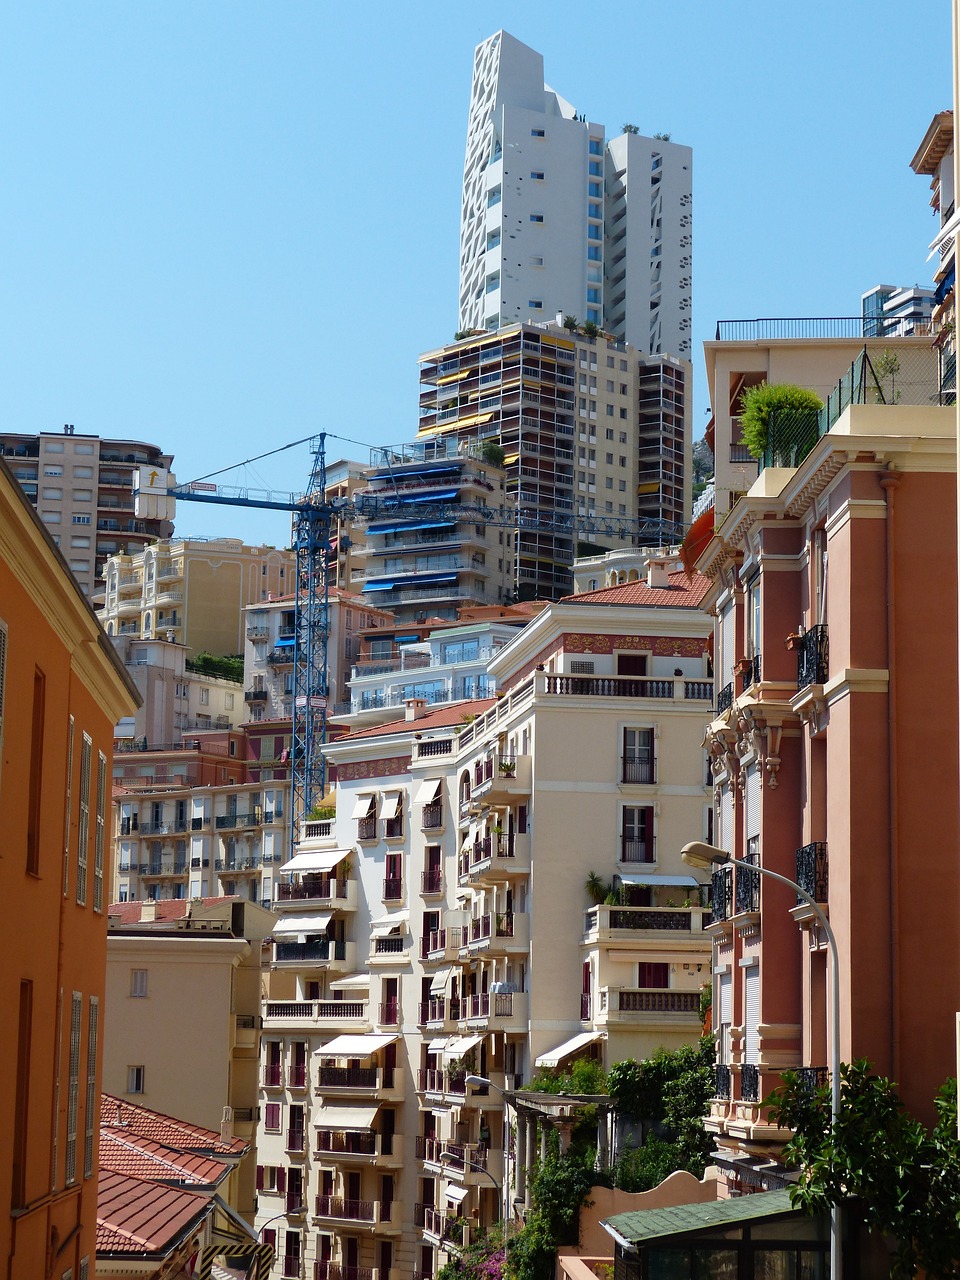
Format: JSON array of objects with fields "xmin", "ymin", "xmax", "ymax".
[{"xmin": 0, "ymin": 460, "xmax": 137, "ymax": 1280}]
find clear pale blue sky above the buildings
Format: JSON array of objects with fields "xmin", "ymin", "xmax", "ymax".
[{"xmin": 0, "ymin": 0, "xmax": 951, "ymax": 541}]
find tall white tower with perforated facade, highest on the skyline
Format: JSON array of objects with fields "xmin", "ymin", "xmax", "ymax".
[{"xmin": 460, "ymin": 31, "xmax": 692, "ymax": 357}]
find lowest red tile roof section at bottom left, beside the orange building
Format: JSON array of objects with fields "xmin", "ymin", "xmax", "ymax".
[{"xmin": 97, "ymin": 1169, "xmax": 212, "ymax": 1257}]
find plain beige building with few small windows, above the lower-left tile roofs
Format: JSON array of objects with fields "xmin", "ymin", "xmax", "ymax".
[{"xmin": 104, "ymin": 897, "xmax": 276, "ymax": 1222}]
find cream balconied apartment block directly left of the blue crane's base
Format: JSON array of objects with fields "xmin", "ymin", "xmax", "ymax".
[{"xmin": 113, "ymin": 773, "xmax": 291, "ymax": 906}]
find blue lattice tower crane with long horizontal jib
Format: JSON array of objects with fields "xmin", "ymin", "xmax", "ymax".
[{"xmin": 156, "ymin": 431, "xmax": 684, "ymax": 847}]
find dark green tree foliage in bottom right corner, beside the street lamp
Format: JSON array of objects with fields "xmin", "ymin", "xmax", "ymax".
[{"xmin": 767, "ymin": 1059, "xmax": 960, "ymax": 1280}]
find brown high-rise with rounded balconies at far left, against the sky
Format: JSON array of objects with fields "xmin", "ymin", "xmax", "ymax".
[{"xmin": 0, "ymin": 426, "xmax": 173, "ymax": 596}]
